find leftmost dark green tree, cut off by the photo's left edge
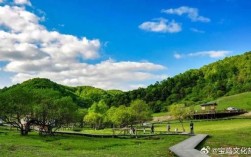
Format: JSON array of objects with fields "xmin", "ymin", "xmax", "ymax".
[{"xmin": 0, "ymin": 87, "xmax": 32, "ymax": 135}]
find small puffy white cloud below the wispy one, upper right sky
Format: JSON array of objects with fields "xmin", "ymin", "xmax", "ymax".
[{"xmin": 139, "ymin": 18, "xmax": 181, "ymax": 33}]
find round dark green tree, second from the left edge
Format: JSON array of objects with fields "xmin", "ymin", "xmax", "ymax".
[{"xmin": 30, "ymin": 89, "xmax": 78, "ymax": 135}]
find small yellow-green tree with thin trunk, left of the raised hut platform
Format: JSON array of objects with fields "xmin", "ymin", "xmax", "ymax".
[{"xmin": 169, "ymin": 104, "xmax": 192, "ymax": 132}]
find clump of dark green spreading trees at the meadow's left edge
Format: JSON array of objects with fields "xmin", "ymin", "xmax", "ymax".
[{"xmin": 0, "ymin": 85, "xmax": 77, "ymax": 135}]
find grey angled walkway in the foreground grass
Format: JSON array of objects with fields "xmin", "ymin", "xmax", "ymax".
[{"xmin": 169, "ymin": 134, "xmax": 209, "ymax": 157}]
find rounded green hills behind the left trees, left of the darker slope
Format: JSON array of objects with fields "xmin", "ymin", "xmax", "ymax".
[{"xmin": 0, "ymin": 78, "xmax": 123, "ymax": 108}]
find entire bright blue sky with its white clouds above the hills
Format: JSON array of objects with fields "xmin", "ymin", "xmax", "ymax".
[{"xmin": 0, "ymin": 0, "xmax": 251, "ymax": 90}]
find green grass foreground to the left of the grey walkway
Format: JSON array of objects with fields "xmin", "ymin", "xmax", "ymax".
[{"xmin": 0, "ymin": 128, "xmax": 187, "ymax": 157}]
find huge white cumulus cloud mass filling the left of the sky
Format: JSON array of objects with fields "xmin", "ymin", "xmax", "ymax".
[{"xmin": 0, "ymin": 4, "xmax": 165, "ymax": 90}]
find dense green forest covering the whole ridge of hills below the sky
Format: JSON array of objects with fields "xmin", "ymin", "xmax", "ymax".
[{"xmin": 0, "ymin": 52, "xmax": 251, "ymax": 112}]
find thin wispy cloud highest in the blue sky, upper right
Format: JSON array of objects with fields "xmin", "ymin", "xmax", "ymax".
[{"xmin": 161, "ymin": 6, "xmax": 210, "ymax": 22}]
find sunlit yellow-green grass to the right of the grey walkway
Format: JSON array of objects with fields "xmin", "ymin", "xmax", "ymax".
[{"xmin": 156, "ymin": 119, "xmax": 251, "ymax": 156}]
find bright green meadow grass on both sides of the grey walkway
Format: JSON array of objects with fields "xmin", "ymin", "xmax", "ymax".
[{"xmin": 0, "ymin": 119, "xmax": 251, "ymax": 157}]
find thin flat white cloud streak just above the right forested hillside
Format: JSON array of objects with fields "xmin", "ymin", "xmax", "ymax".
[{"xmin": 188, "ymin": 50, "xmax": 231, "ymax": 58}]
